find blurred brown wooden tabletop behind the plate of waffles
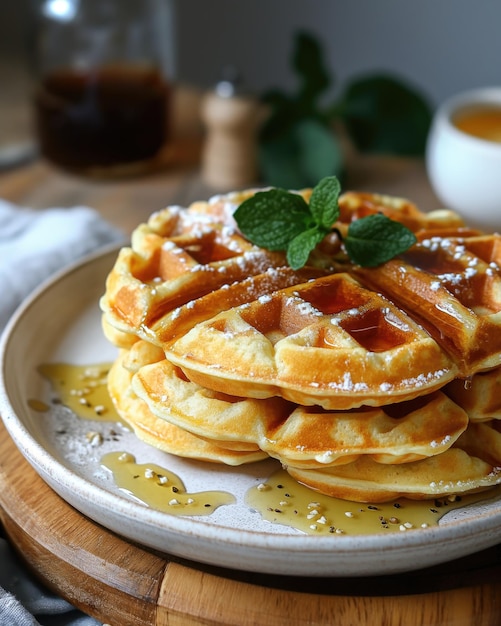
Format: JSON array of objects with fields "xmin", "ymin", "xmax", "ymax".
[{"xmin": 0, "ymin": 145, "xmax": 440, "ymax": 233}]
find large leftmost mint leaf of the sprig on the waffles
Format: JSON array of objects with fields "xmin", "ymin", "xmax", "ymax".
[{"xmin": 233, "ymin": 189, "xmax": 311, "ymax": 250}]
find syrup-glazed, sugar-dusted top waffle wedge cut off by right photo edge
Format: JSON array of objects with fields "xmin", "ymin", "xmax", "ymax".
[{"xmin": 352, "ymin": 235, "xmax": 501, "ymax": 377}]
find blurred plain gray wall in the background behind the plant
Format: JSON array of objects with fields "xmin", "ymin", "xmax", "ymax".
[{"xmin": 0, "ymin": 0, "xmax": 501, "ymax": 105}]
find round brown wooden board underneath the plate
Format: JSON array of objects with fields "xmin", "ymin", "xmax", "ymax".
[{"xmin": 0, "ymin": 414, "xmax": 501, "ymax": 626}]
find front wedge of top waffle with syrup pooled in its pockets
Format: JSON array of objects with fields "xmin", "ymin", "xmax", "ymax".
[{"xmin": 166, "ymin": 273, "xmax": 456, "ymax": 409}]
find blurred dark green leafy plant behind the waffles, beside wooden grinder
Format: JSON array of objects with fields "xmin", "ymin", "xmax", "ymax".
[{"xmin": 259, "ymin": 31, "xmax": 432, "ymax": 189}]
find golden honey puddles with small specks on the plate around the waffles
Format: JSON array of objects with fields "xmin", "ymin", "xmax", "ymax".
[{"xmin": 29, "ymin": 363, "xmax": 500, "ymax": 536}]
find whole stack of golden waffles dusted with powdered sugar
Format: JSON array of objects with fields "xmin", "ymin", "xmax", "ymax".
[{"xmin": 101, "ymin": 190, "xmax": 501, "ymax": 503}]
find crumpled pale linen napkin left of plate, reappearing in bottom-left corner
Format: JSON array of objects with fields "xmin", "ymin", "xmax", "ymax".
[{"xmin": 0, "ymin": 199, "xmax": 124, "ymax": 626}]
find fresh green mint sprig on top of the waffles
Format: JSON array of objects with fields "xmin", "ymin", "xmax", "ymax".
[{"xmin": 234, "ymin": 176, "xmax": 416, "ymax": 269}]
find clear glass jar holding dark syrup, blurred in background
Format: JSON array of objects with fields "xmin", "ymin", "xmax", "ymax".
[{"xmin": 34, "ymin": 0, "xmax": 173, "ymax": 174}]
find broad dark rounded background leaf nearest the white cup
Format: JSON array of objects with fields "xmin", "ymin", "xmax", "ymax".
[{"xmin": 336, "ymin": 74, "xmax": 432, "ymax": 156}]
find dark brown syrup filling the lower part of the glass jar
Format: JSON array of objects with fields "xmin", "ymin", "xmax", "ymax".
[{"xmin": 35, "ymin": 65, "xmax": 169, "ymax": 170}]
